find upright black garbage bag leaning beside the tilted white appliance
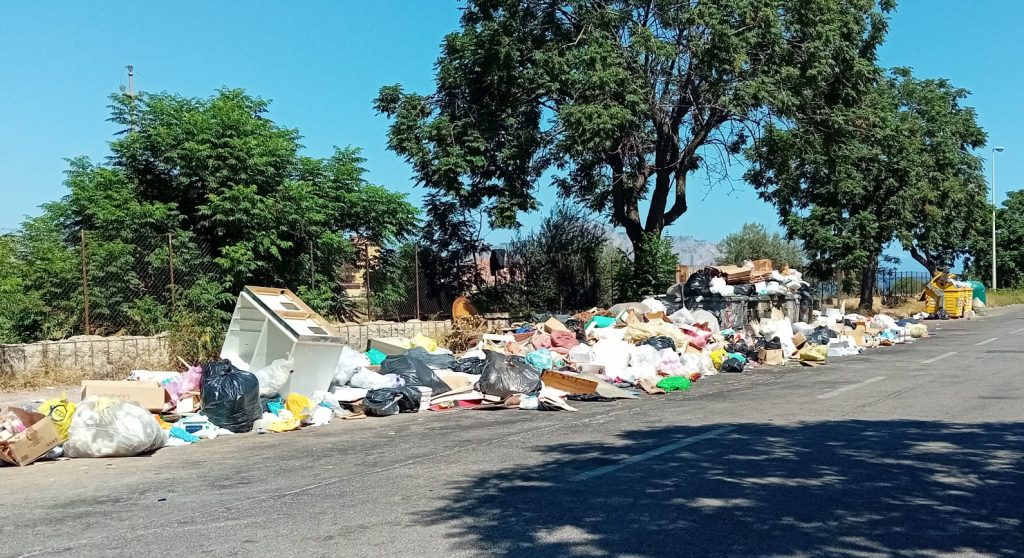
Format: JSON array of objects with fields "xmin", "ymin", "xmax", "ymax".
[{"xmin": 200, "ymin": 358, "xmax": 263, "ymax": 433}]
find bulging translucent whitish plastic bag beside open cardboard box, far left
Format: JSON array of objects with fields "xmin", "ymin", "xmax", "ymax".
[{"xmin": 65, "ymin": 395, "xmax": 167, "ymax": 458}]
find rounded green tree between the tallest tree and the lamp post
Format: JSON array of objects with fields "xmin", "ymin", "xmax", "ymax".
[{"xmin": 746, "ymin": 69, "xmax": 985, "ymax": 306}]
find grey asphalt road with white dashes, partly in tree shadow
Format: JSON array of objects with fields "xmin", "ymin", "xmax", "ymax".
[{"xmin": 0, "ymin": 307, "xmax": 1024, "ymax": 558}]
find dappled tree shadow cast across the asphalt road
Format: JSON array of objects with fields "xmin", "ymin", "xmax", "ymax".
[{"xmin": 414, "ymin": 420, "xmax": 1024, "ymax": 557}]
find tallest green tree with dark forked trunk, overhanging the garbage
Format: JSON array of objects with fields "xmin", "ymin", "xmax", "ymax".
[{"xmin": 376, "ymin": 0, "xmax": 894, "ymax": 282}]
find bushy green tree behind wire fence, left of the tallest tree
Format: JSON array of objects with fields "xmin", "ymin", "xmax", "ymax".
[{"xmin": 0, "ymin": 89, "xmax": 418, "ymax": 340}]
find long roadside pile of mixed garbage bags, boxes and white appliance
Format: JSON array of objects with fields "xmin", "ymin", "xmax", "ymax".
[{"xmin": 0, "ymin": 280, "xmax": 928, "ymax": 465}]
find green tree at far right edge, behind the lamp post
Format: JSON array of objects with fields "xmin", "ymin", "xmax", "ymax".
[{"xmin": 967, "ymin": 190, "xmax": 1024, "ymax": 289}]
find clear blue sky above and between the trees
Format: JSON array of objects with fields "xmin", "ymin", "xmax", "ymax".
[{"xmin": 0, "ymin": 0, "xmax": 1024, "ymax": 268}]
